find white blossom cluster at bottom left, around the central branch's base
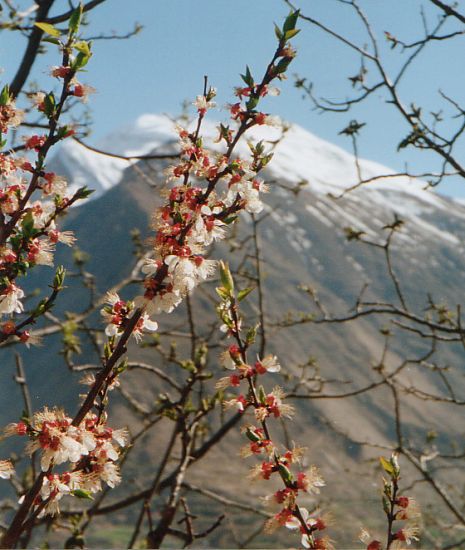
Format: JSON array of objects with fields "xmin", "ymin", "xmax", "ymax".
[{"xmin": 4, "ymin": 408, "xmax": 128, "ymax": 515}]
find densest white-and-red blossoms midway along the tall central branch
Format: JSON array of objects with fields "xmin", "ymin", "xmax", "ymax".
[{"xmin": 131, "ymin": 118, "xmax": 265, "ymax": 320}]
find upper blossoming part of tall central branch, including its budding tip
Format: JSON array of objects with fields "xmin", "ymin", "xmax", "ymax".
[{"xmin": 106, "ymin": 16, "xmax": 297, "ymax": 342}]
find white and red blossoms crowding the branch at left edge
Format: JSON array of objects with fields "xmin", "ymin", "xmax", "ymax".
[{"xmin": 0, "ymin": 55, "xmax": 92, "ymax": 342}]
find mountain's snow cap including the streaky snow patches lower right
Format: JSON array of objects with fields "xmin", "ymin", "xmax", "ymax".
[{"xmin": 51, "ymin": 114, "xmax": 465, "ymax": 266}]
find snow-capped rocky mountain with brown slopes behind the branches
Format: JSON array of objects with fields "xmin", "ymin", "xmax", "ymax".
[{"xmin": 0, "ymin": 115, "xmax": 465, "ymax": 548}]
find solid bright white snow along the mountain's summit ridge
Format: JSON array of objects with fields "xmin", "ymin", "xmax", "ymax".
[{"xmin": 48, "ymin": 114, "xmax": 447, "ymax": 215}]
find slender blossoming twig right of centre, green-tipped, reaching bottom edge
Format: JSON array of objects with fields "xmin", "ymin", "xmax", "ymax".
[{"xmin": 217, "ymin": 263, "xmax": 332, "ymax": 548}]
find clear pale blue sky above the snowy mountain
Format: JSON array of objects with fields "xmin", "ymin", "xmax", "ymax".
[{"xmin": 0, "ymin": 0, "xmax": 465, "ymax": 197}]
